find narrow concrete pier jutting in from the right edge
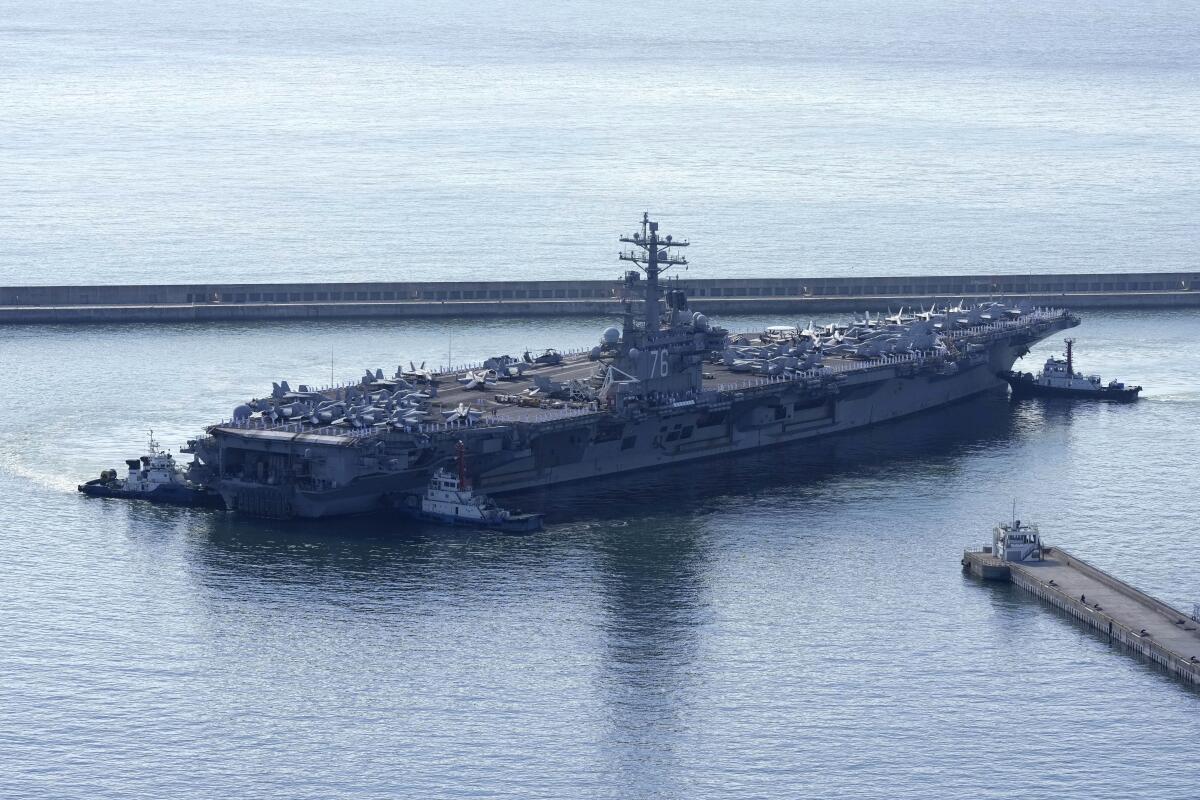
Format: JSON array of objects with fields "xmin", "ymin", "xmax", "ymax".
[{"xmin": 962, "ymin": 547, "xmax": 1200, "ymax": 686}]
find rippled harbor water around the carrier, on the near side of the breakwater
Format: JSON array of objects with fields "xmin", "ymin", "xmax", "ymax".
[{"xmin": 0, "ymin": 312, "xmax": 1200, "ymax": 799}]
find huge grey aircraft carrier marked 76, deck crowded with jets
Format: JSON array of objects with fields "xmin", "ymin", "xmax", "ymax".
[{"xmin": 185, "ymin": 215, "xmax": 1079, "ymax": 518}]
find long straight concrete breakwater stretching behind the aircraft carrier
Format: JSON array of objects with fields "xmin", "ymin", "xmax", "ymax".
[{"xmin": 0, "ymin": 272, "xmax": 1200, "ymax": 324}]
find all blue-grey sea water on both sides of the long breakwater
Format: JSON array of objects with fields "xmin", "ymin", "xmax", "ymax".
[{"xmin": 0, "ymin": 0, "xmax": 1200, "ymax": 800}]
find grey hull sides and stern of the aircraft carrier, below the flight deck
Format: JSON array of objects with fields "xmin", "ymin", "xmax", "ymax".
[{"xmin": 189, "ymin": 312, "xmax": 1078, "ymax": 517}]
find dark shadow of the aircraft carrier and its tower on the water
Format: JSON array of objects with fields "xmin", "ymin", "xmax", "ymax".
[{"xmin": 150, "ymin": 396, "xmax": 1060, "ymax": 777}]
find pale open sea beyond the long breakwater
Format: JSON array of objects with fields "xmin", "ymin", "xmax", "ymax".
[{"xmin": 0, "ymin": 0, "xmax": 1200, "ymax": 285}]
